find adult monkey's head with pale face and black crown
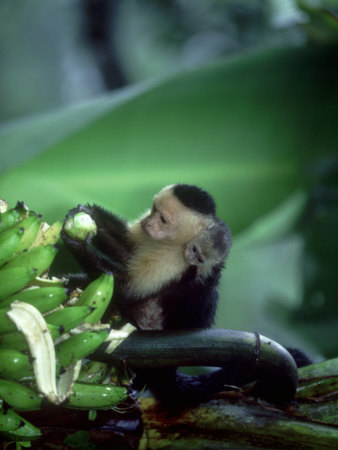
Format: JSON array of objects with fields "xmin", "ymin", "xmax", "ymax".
[{"xmin": 141, "ymin": 184, "xmax": 216, "ymax": 245}]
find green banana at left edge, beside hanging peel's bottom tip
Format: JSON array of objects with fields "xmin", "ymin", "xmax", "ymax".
[{"xmin": 0, "ymin": 378, "xmax": 42, "ymax": 411}]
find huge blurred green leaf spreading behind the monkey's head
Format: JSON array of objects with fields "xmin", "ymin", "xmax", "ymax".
[{"xmin": 0, "ymin": 43, "xmax": 338, "ymax": 232}]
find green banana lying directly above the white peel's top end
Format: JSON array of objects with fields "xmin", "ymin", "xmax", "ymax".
[{"xmin": 0, "ymin": 286, "xmax": 67, "ymax": 314}]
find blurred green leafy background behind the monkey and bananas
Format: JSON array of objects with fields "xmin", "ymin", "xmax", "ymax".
[{"xmin": 0, "ymin": 0, "xmax": 338, "ymax": 357}]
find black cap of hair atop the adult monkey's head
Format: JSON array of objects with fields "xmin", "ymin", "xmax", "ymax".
[{"xmin": 173, "ymin": 184, "xmax": 216, "ymax": 215}]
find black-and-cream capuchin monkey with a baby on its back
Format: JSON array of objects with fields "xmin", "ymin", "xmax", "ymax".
[{"xmin": 62, "ymin": 184, "xmax": 308, "ymax": 402}]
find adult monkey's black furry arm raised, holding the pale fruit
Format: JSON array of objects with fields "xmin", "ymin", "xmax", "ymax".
[{"xmin": 61, "ymin": 205, "xmax": 132, "ymax": 278}]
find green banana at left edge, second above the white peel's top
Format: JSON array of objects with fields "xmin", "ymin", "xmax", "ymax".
[{"xmin": 0, "ymin": 264, "xmax": 37, "ymax": 301}]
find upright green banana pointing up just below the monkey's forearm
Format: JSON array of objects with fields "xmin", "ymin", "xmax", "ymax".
[{"xmin": 76, "ymin": 273, "xmax": 114, "ymax": 323}]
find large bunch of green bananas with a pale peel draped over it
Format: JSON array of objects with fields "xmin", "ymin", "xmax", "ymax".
[{"xmin": 0, "ymin": 201, "xmax": 127, "ymax": 441}]
